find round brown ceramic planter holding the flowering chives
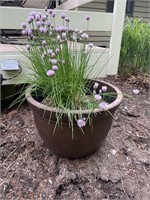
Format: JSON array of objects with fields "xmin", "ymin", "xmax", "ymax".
[{"xmin": 26, "ymin": 81, "xmax": 122, "ymax": 159}]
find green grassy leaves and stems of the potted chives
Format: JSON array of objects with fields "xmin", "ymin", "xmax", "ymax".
[{"xmin": 24, "ymin": 22, "xmax": 95, "ymax": 110}]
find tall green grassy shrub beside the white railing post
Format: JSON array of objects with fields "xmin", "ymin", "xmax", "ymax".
[{"xmin": 119, "ymin": 18, "xmax": 150, "ymax": 77}]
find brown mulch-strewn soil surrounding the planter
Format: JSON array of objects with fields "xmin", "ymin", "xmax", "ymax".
[{"xmin": 0, "ymin": 76, "xmax": 150, "ymax": 200}]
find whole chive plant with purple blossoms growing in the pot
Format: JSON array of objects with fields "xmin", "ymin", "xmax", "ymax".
[{"xmin": 19, "ymin": 9, "xmax": 113, "ymax": 128}]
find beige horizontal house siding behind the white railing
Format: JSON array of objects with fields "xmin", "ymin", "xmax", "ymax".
[{"xmin": 78, "ymin": 0, "xmax": 150, "ymax": 47}]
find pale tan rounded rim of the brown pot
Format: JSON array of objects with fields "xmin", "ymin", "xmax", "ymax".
[{"xmin": 25, "ymin": 79, "xmax": 123, "ymax": 114}]
